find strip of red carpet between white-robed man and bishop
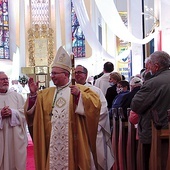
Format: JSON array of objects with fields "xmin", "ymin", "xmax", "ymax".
[{"xmin": 26, "ymin": 135, "xmax": 35, "ymax": 170}]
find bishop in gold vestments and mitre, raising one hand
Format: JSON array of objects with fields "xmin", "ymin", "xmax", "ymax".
[{"xmin": 25, "ymin": 46, "xmax": 101, "ymax": 170}]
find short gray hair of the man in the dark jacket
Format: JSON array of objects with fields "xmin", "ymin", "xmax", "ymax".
[{"xmin": 149, "ymin": 51, "xmax": 170, "ymax": 68}]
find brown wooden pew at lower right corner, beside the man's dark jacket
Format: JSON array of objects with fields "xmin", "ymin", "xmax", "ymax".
[{"xmin": 150, "ymin": 110, "xmax": 170, "ymax": 170}]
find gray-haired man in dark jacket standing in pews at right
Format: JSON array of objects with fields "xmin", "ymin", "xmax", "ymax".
[{"xmin": 131, "ymin": 51, "xmax": 170, "ymax": 170}]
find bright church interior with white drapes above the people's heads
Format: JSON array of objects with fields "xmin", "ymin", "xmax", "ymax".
[{"xmin": 0, "ymin": 0, "xmax": 170, "ymax": 91}]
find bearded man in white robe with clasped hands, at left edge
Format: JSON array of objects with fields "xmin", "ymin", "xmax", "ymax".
[{"xmin": 0, "ymin": 71, "xmax": 28, "ymax": 170}]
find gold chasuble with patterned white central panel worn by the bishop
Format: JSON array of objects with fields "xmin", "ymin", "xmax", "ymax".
[{"xmin": 29, "ymin": 85, "xmax": 101, "ymax": 170}]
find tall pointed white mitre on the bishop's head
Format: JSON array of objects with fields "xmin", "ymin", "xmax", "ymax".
[{"xmin": 51, "ymin": 46, "xmax": 71, "ymax": 72}]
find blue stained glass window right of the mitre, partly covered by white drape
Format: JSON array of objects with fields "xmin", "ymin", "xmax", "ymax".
[{"xmin": 71, "ymin": 2, "xmax": 85, "ymax": 57}]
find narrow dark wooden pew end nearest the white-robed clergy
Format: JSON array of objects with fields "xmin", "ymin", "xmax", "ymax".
[{"xmin": 112, "ymin": 108, "xmax": 119, "ymax": 170}]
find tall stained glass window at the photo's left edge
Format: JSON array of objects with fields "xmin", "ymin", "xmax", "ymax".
[{"xmin": 0, "ymin": 0, "xmax": 10, "ymax": 59}]
